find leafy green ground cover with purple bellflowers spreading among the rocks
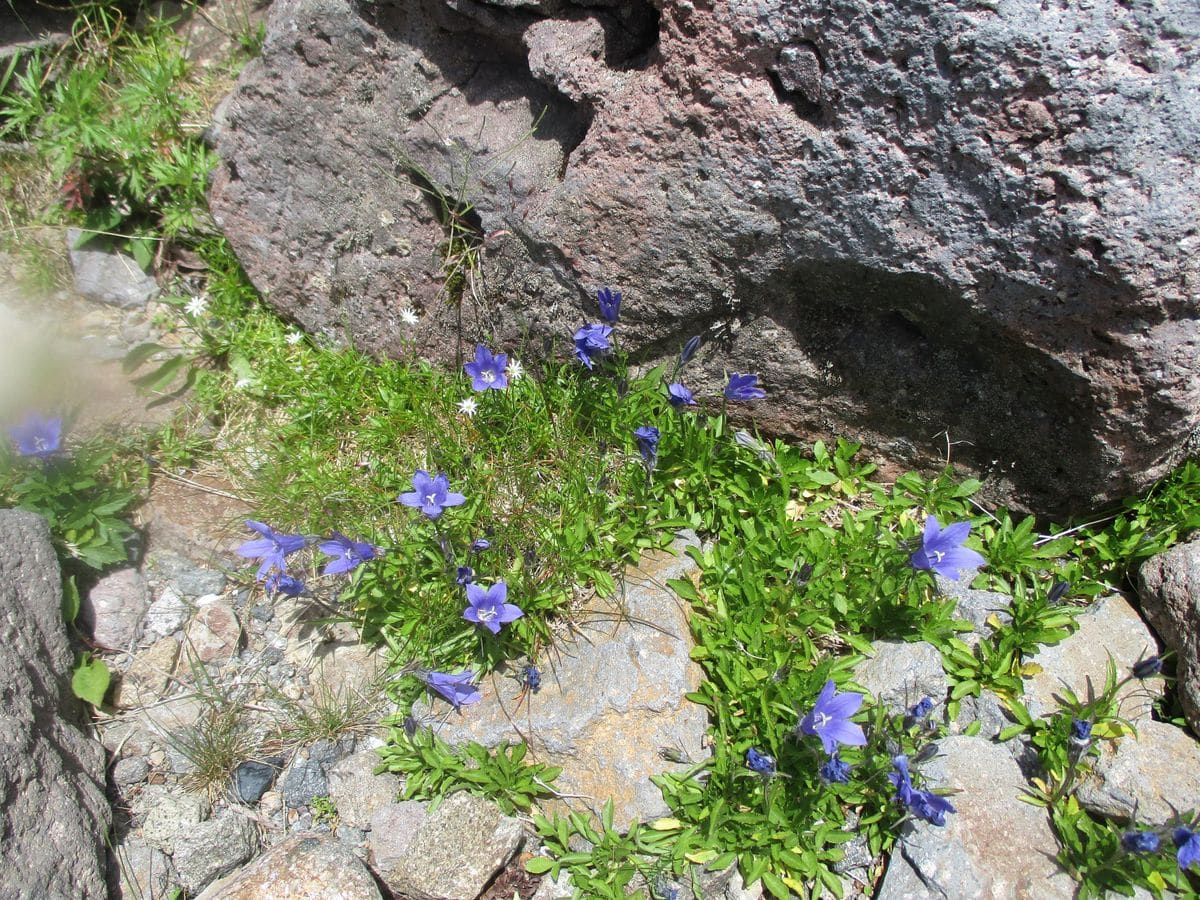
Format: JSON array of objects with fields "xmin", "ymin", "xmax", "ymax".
[{"xmin": 0, "ymin": 5, "xmax": 1200, "ymax": 896}]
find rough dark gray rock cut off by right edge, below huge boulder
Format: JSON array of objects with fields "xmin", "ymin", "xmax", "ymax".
[{"xmin": 1138, "ymin": 539, "xmax": 1200, "ymax": 734}]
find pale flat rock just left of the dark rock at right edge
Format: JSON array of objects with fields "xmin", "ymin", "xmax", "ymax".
[{"xmin": 1024, "ymin": 594, "xmax": 1164, "ymax": 725}]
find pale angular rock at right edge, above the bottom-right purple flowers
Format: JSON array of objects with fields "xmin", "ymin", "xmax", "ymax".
[{"xmin": 1075, "ymin": 720, "xmax": 1200, "ymax": 826}]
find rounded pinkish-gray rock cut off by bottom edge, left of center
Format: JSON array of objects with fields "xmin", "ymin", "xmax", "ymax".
[{"xmin": 197, "ymin": 834, "xmax": 382, "ymax": 900}]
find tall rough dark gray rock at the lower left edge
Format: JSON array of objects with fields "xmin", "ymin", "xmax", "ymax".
[{"xmin": 0, "ymin": 510, "xmax": 112, "ymax": 900}]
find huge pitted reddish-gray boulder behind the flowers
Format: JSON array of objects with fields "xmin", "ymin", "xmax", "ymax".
[{"xmin": 211, "ymin": 0, "xmax": 1200, "ymax": 510}]
